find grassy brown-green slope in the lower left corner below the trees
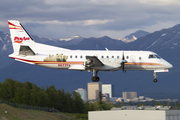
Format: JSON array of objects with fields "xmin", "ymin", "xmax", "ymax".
[{"xmin": 0, "ymin": 104, "xmax": 73, "ymax": 120}]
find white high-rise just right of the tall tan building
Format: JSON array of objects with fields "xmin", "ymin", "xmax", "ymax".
[{"xmin": 102, "ymin": 84, "xmax": 112, "ymax": 98}]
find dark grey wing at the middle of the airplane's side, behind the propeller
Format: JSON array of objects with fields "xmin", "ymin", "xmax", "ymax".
[{"xmin": 86, "ymin": 56, "xmax": 104, "ymax": 67}]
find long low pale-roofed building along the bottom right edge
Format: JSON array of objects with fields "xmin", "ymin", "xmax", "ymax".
[{"xmin": 88, "ymin": 110, "xmax": 180, "ymax": 120}]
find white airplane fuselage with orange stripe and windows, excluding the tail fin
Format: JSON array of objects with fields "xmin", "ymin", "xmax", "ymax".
[{"xmin": 10, "ymin": 46, "xmax": 172, "ymax": 71}]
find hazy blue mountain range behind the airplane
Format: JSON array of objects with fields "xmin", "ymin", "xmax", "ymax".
[{"xmin": 0, "ymin": 25, "xmax": 180, "ymax": 97}]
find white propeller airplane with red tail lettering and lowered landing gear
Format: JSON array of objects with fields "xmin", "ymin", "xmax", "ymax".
[{"xmin": 8, "ymin": 20, "xmax": 173, "ymax": 83}]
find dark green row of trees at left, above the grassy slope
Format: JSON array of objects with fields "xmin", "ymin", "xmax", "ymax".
[{"xmin": 0, "ymin": 78, "xmax": 112, "ymax": 113}]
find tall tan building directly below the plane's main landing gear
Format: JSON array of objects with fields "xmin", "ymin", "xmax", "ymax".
[{"xmin": 88, "ymin": 82, "xmax": 102, "ymax": 100}]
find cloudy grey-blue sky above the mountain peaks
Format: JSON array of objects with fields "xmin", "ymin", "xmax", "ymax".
[{"xmin": 0, "ymin": 0, "xmax": 180, "ymax": 38}]
